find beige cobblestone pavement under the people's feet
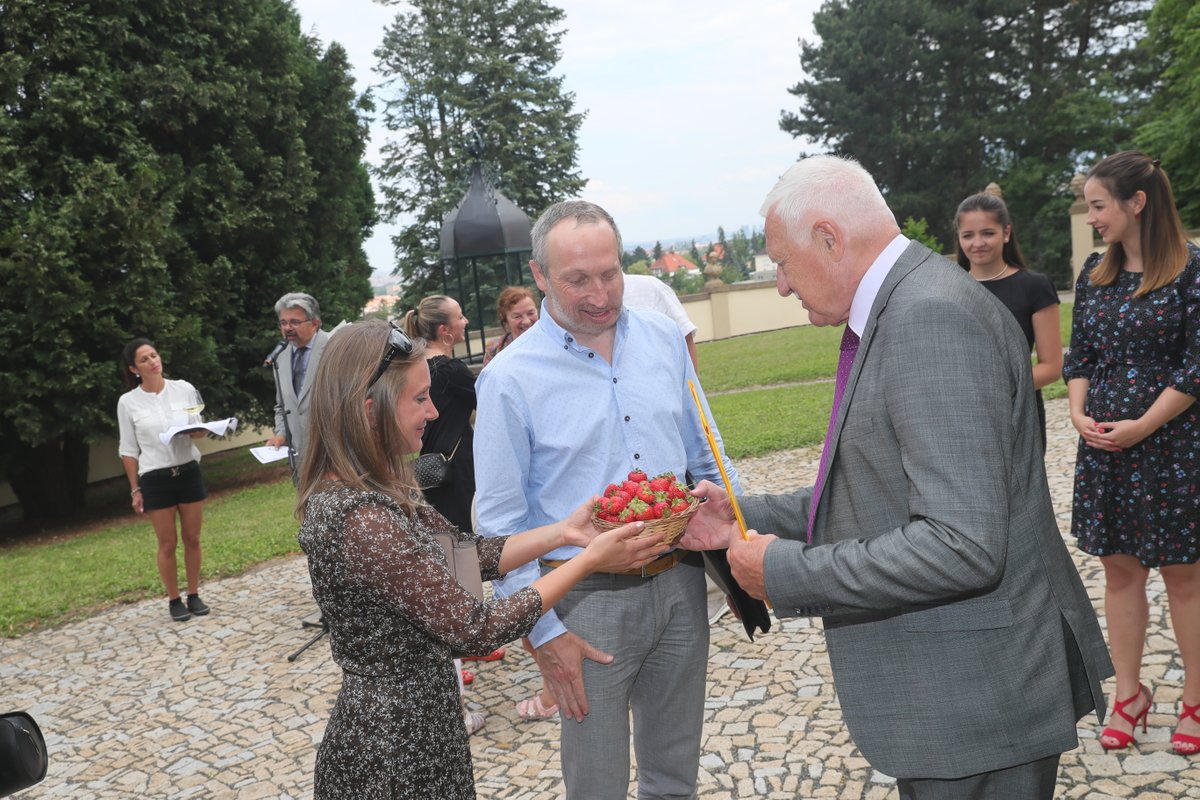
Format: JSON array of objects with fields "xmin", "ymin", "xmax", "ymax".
[{"xmin": 0, "ymin": 401, "xmax": 1200, "ymax": 800}]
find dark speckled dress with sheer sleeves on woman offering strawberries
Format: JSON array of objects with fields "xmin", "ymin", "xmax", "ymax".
[{"xmin": 300, "ymin": 483, "xmax": 541, "ymax": 800}]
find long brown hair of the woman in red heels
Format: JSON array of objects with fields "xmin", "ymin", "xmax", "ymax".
[{"xmin": 1087, "ymin": 150, "xmax": 1188, "ymax": 297}]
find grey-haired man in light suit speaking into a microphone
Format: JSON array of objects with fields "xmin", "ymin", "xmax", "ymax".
[{"xmin": 266, "ymin": 291, "xmax": 329, "ymax": 483}]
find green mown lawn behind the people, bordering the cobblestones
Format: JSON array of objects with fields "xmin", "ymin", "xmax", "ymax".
[{"xmin": 0, "ymin": 305, "xmax": 1070, "ymax": 637}]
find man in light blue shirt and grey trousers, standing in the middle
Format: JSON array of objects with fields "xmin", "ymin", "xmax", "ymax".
[{"xmin": 475, "ymin": 200, "xmax": 737, "ymax": 800}]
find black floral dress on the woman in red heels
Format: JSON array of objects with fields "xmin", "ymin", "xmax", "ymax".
[{"xmin": 1063, "ymin": 245, "xmax": 1200, "ymax": 566}]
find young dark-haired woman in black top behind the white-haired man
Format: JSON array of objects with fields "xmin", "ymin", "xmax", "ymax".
[{"xmin": 954, "ymin": 192, "xmax": 1062, "ymax": 452}]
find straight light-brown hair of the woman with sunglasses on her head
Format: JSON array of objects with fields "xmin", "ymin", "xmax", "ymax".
[{"xmin": 296, "ymin": 319, "xmax": 425, "ymax": 519}]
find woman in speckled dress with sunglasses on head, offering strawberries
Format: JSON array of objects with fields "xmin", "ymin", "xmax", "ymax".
[{"xmin": 298, "ymin": 320, "xmax": 662, "ymax": 800}]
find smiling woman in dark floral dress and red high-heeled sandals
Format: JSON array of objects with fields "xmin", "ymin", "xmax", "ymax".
[{"xmin": 1063, "ymin": 152, "xmax": 1200, "ymax": 756}]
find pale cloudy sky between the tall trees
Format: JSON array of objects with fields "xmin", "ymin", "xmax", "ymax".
[{"xmin": 293, "ymin": 0, "xmax": 821, "ymax": 276}]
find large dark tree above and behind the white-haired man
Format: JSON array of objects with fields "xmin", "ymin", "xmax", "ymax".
[{"xmin": 780, "ymin": 0, "xmax": 1150, "ymax": 287}]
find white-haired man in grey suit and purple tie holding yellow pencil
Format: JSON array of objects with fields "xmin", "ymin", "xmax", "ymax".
[{"xmin": 682, "ymin": 156, "xmax": 1112, "ymax": 800}]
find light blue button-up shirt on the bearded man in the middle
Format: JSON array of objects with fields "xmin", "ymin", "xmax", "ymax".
[{"xmin": 475, "ymin": 301, "xmax": 740, "ymax": 646}]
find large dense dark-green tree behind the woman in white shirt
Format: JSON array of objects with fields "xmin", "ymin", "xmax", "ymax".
[{"xmin": 0, "ymin": 0, "xmax": 374, "ymax": 521}]
